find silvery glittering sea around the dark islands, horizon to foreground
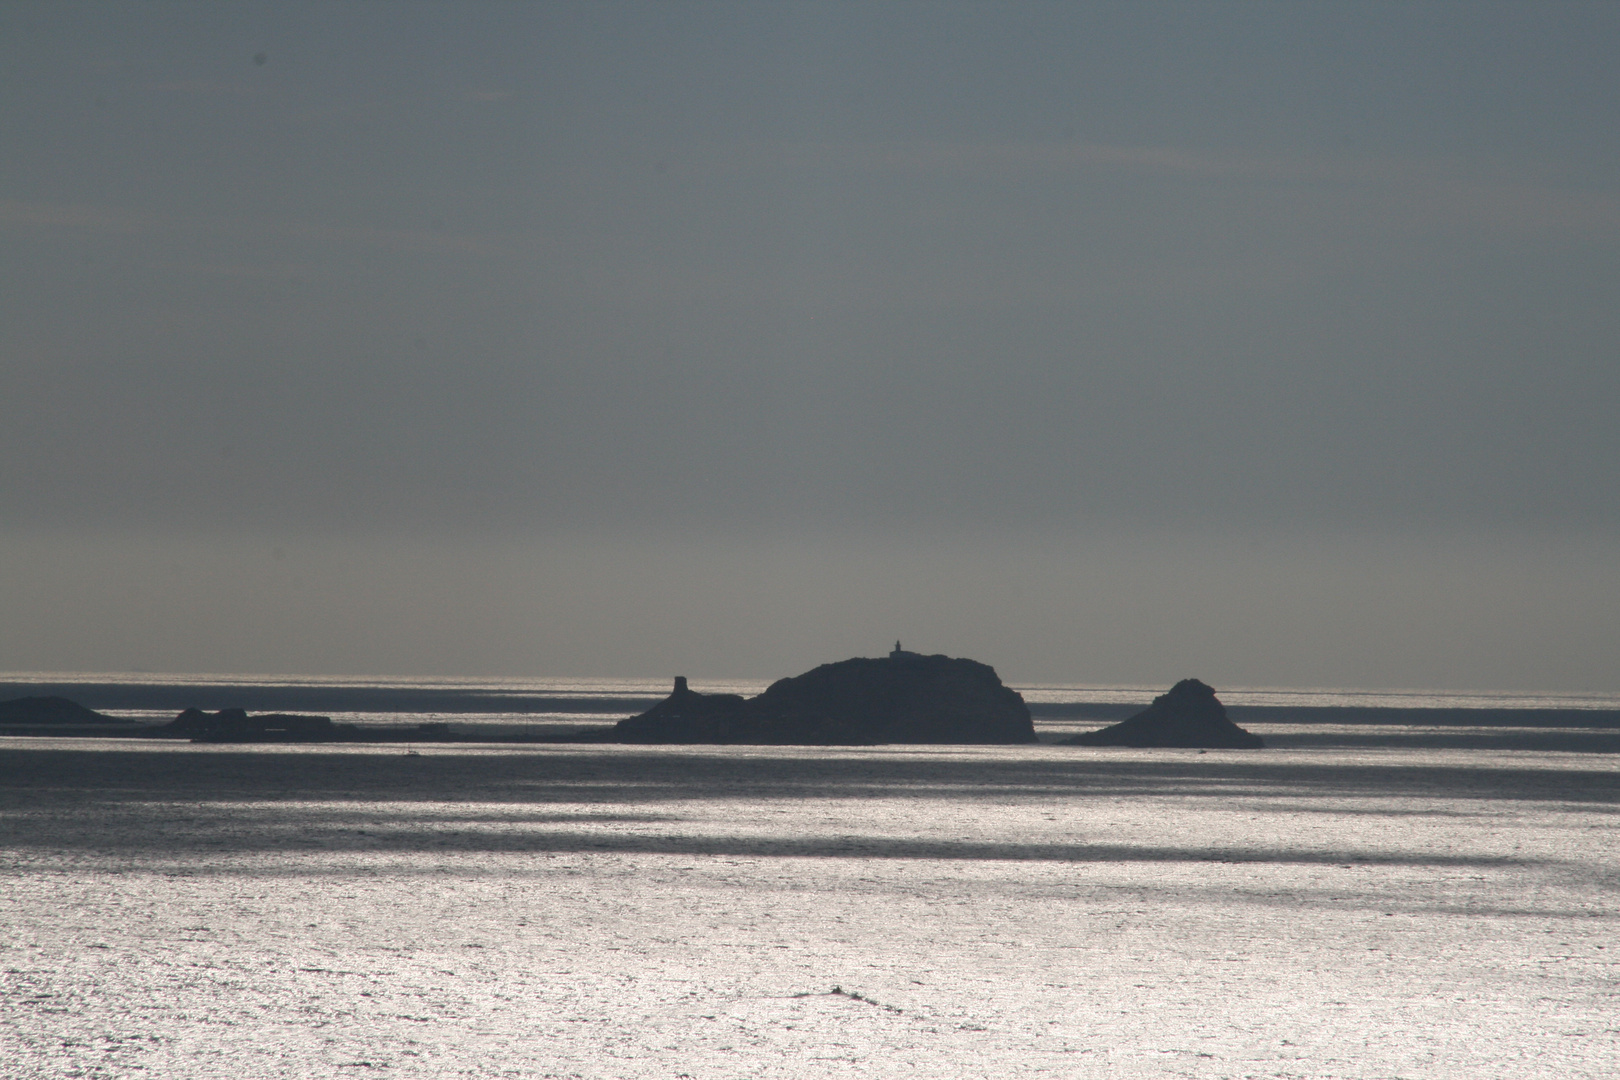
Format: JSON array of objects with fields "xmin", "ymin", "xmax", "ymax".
[{"xmin": 0, "ymin": 672, "xmax": 1620, "ymax": 1080}]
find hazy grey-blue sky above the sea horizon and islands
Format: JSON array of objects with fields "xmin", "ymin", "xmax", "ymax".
[{"xmin": 0, "ymin": 2, "xmax": 1620, "ymax": 690}]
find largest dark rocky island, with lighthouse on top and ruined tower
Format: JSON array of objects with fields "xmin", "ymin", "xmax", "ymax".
[{"xmin": 599, "ymin": 641, "xmax": 1037, "ymax": 746}]
